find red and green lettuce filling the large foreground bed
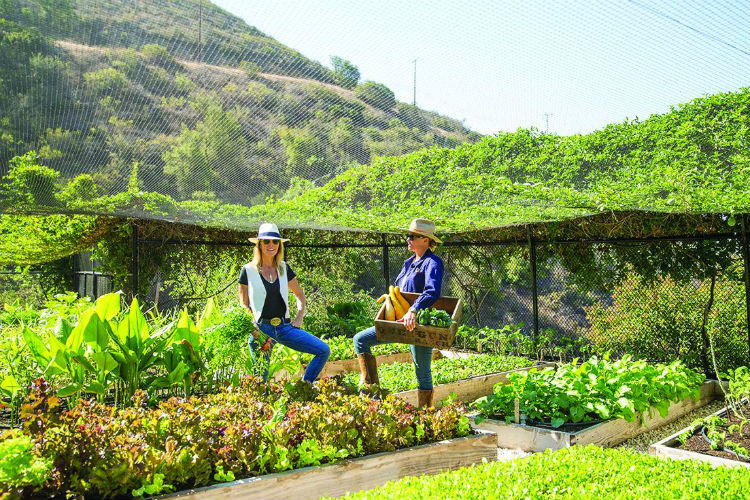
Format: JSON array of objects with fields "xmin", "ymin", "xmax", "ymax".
[{"xmin": 0, "ymin": 378, "xmax": 471, "ymax": 498}]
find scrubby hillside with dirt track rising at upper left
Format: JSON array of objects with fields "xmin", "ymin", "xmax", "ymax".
[{"xmin": 0, "ymin": 0, "xmax": 479, "ymax": 206}]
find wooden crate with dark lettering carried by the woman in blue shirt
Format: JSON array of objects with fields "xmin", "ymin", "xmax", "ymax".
[{"xmin": 375, "ymin": 292, "xmax": 463, "ymax": 349}]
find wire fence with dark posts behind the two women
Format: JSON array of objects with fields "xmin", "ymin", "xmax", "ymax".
[{"xmin": 75, "ymin": 228, "xmax": 750, "ymax": 374}]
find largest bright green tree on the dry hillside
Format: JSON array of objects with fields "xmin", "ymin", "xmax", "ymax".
[{"xmin": 162, "ymin": 99, "xmax": 247, "ymax": 198}]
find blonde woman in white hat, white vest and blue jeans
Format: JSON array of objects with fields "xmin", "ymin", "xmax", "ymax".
[{"xmin": 239, "ymin": 222, "xmax": 331, "ymax": 382}]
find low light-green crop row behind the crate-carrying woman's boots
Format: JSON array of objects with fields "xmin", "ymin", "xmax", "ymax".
[{"xmin": 346, "ymin": 354, "xmax": 534, "ymax": 392}]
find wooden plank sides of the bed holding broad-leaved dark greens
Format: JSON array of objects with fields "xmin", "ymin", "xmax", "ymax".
[{"xmin": 473, "ymin": 380, "xmax": 723, "ymax": 451}]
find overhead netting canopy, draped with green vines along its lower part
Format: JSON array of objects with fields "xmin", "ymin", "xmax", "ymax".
[{"xmin": 0, "ymin": 0, "xmax": 750, "ymax": 244}]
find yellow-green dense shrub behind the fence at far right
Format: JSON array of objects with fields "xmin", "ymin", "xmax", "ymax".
[{"xmin": 586, "ymin": 275, "xmax": 748, "ymax": 372}]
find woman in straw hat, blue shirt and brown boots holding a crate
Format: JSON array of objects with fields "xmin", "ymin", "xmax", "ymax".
[{"xmin": 354, "ymin": 219, "xmax": 443, "ymax": 407}]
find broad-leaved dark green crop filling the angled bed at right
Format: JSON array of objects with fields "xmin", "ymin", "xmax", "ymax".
[{"xmin": 476, "ymin": 355, "xmax": 705, "ymax": 427}]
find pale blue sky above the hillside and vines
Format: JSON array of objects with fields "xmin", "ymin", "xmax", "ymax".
[{"xmin": 214, "ymin": 0, "xmax": 750, "ymax": 135}]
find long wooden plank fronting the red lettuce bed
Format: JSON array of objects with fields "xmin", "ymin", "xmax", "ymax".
[{"xmin": 158, "ymin": 432, "xmax": 497, "ymax": 500}]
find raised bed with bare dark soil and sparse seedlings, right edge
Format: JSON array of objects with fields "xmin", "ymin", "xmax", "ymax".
[{"xmin": 648, "ymin": 404, "xmax": 750, "ymax": 468}]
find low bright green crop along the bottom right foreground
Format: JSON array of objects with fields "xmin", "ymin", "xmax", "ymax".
[{"xmin": 332, "ymin": 445, "xmax": 750, "ymax": 500}]
